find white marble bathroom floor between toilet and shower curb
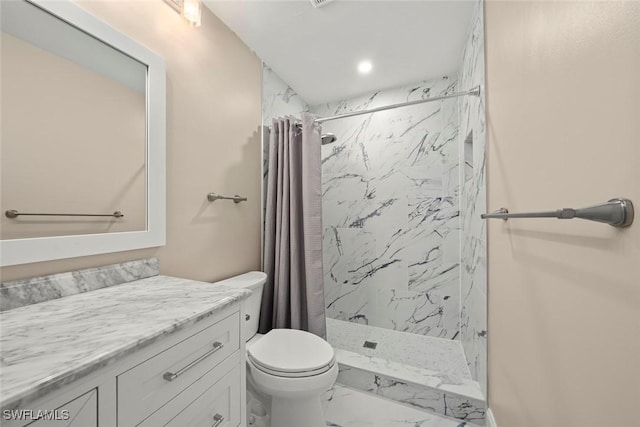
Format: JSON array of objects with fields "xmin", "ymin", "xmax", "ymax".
[{"xmin": 323, "ymin": 384, "xmax": 469, "ymax": 427}]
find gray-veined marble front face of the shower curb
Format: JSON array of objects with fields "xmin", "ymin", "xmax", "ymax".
[{"xmin": 337, "ymin": 366, "xmax": 485, "ymax": 425}]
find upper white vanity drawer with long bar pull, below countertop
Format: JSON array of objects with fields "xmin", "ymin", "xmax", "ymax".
[{"xmin": 117, "ymin": 312, "xmax": 240, "ymax": 427}]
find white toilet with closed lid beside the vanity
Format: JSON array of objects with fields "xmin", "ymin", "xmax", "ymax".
[{"xmin": 218, "ymin": 271, "xmax": 338, "ymax": 427}]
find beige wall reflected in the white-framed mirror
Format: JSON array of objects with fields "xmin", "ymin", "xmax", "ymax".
[{"xmin": 0, "ymin": 32, "xmax": 146, "ymax": 239}]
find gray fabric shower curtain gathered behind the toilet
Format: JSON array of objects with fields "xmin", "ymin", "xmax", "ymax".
[{"xmin": 259, "ymin": 113, "xmax": 326, "ymax": 337}]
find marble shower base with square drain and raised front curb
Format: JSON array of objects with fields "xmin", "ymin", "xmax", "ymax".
[{"xmin": 327, "ymin": 319, "xmax": 486, "ymax": 425}]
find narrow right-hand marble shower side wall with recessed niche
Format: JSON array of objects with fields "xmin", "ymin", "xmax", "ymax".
[{"xmin": 459, "ymin": 0, "xmax": 487, "ymax": 396}]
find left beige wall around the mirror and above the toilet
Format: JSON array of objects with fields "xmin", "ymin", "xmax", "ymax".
[{"xmin": 1, "ymin": 0, "xmax": 262, "ymax": 281}]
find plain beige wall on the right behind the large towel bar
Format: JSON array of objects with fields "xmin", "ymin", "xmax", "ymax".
[{"xmin": 486, "ymin": 1, "xmax": 640, "ymax": 427}]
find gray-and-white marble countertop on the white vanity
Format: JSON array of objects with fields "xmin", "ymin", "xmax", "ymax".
[{"xmin": 0, "ymin": 276, "xmax": 251, "ymax": 409}]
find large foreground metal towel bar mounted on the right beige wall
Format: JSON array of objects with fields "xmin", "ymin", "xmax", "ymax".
[{"xmin": 480, "ymin": 198, "xmax": 633, "ymax": 227}]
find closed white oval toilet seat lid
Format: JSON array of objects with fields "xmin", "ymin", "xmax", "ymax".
[{"xmin": 247, "ymin": 329, "xmax": 335, "ymax": 375}]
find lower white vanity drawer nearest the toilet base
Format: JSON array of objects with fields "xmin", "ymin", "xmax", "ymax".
[{"xmin": 139, "ymin": 364, "xmax": 242, "ymax": 427}]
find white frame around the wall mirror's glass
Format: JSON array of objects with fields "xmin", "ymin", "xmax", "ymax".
[{"xmin": 0, "ymin": 0, "xmax": 166, "ymax": 266}]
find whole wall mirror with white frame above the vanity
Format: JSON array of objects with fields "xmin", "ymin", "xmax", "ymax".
[{"xmin": 0, "ymin": 0, "xmax": 165, "ymax": 266}]
